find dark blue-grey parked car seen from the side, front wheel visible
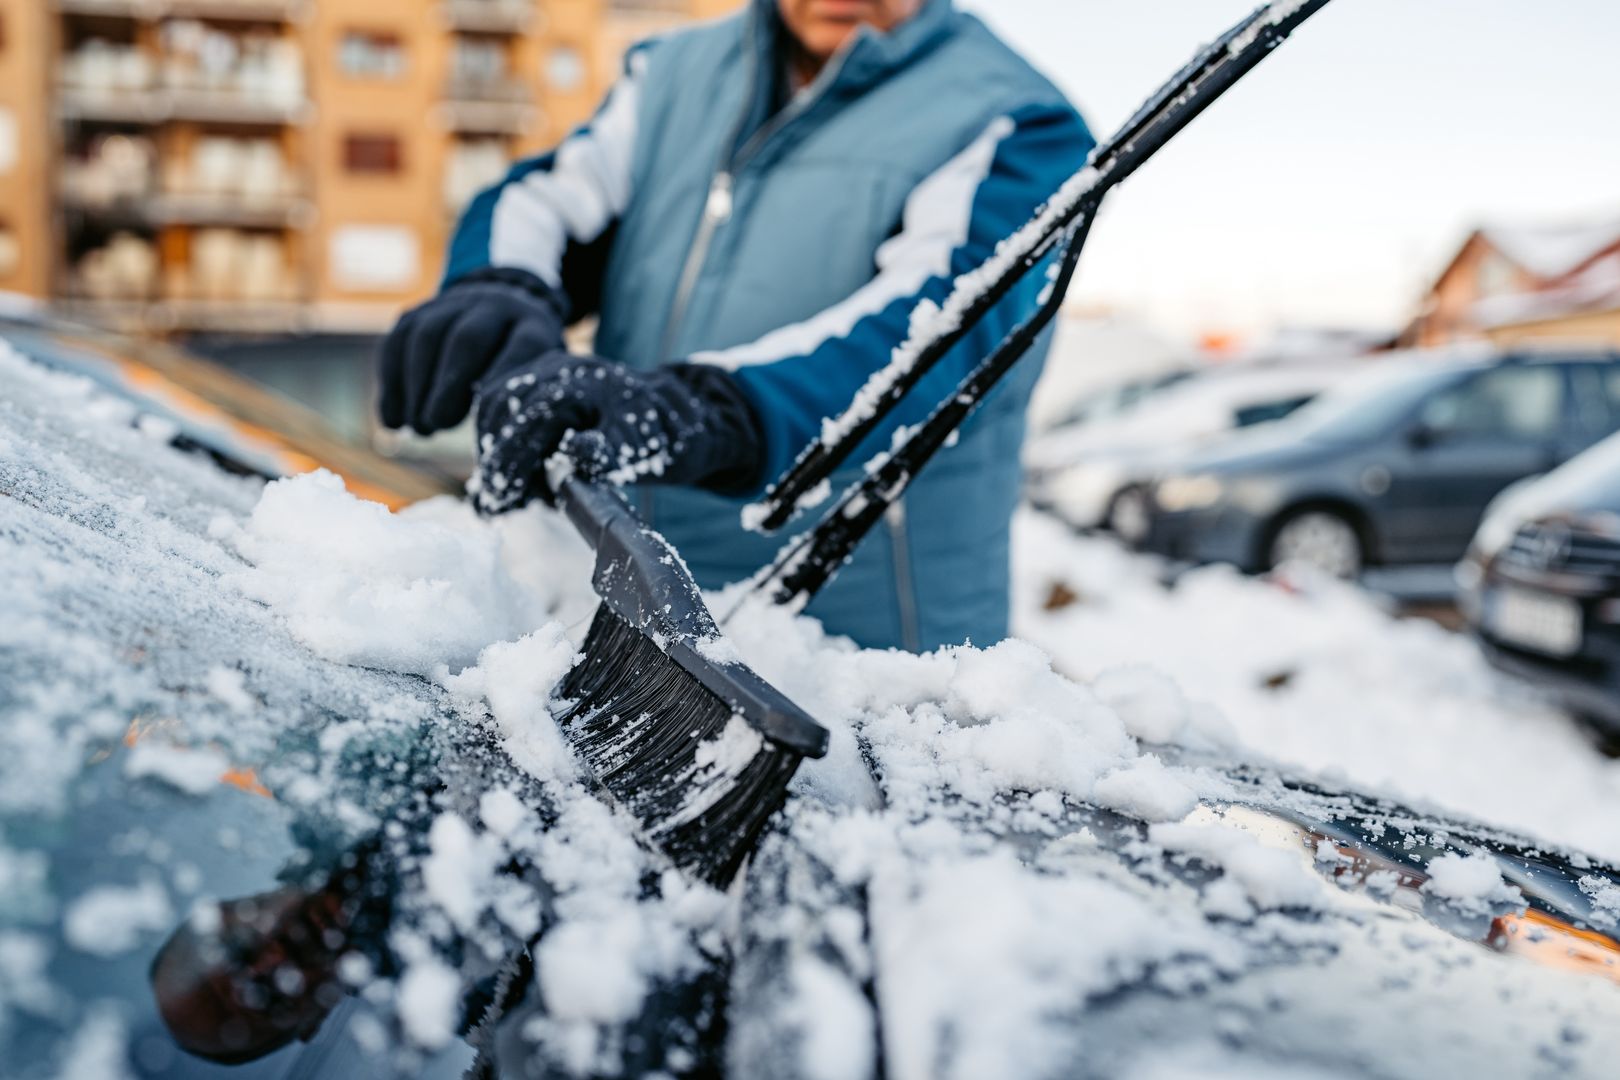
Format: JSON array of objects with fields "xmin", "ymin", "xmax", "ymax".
[{"xmin": 1140, "ymin": 350, "xmax": 1620, "ymax": 578}]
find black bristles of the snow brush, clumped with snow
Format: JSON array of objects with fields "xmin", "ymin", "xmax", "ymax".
[{"xmin": 559, "ymin": 606, "xmax": 804, "ymax": 886}]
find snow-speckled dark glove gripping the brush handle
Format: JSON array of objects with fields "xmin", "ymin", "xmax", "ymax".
[{"xmin": 476, "ymin": 351, "xmax": 765, "ymax": 513}]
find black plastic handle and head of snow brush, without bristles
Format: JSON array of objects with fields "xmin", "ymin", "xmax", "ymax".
[{"xmin": 557, "ymin": 476, "xmax": 828, "ymax": 758}]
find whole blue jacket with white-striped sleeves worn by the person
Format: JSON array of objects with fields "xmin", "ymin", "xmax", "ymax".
[{"xmin": 446, "ymin": 0, "xmax": 1092, "ymax": 651}]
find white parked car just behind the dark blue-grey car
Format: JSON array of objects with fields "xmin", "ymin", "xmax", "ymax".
[{"xmin": 1024, "ymin": 363, "xmax": 1358, "ymax": 536}]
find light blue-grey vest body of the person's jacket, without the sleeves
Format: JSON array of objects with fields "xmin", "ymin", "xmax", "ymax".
[{"xmin": 596, "ymin": 0, "xmax": 1090, "ymax": 651}]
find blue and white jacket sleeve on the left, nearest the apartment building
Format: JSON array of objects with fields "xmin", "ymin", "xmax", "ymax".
[{"xmin": 441, "ymin": 45, "xmax": 646, "ymax": 317}]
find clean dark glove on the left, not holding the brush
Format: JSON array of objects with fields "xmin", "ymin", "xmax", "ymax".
[{"xmin": 377, "ymin": 267, "xmax": 565, "ymax": 436}]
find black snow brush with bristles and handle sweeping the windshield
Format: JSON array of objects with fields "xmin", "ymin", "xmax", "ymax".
[{"xmin": 556, "ymin": 476, "xmax": 828, "ymax": 886}]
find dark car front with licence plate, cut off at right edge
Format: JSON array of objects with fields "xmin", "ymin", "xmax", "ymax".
[{"xmin": 1458, "ymin": 436, "xmax": 1620, "ymax": 738}]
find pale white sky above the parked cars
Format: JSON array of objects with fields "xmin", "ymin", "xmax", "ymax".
[{"xmin": 957, "ymin": 0, "xmax": 1620, "ymax": 344}]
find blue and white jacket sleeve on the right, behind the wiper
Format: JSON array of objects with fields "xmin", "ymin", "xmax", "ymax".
[{"xmin": 690, "ymin": 105, "xmax": 1095, "ymax": 479}]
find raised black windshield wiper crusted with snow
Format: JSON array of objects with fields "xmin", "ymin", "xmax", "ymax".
[{"xmin": 744, "ymin": 0, "xmax": 1328, "ymax": 609}]
